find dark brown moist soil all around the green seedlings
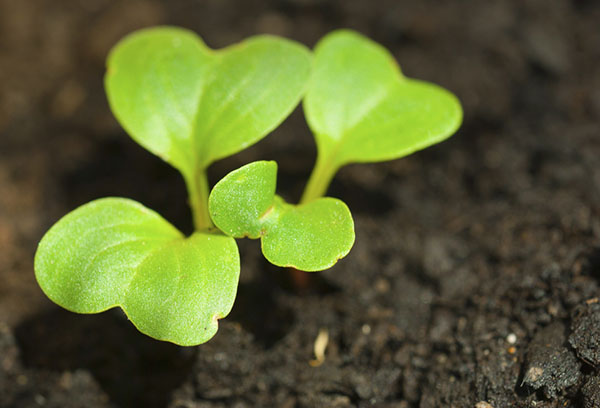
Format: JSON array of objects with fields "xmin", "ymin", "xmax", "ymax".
[{"xmin": 0, "ymin": 0, "xmax": 600, "ymax": 408}]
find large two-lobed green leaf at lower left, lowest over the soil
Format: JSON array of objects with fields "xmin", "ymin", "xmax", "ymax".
[{"xmin": 35, "ymin": 198, "xmax": 240, "ymax": 345}]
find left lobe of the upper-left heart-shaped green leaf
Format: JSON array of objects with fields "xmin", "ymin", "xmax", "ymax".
[{"xmin": 104, "ymin": 27, "xmax": 215, "ymax": 173}]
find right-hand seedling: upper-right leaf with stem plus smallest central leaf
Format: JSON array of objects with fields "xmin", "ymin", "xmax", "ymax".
[{"xmin": 209, "ymin": 30, "xmax": 462, "ymax": 271}]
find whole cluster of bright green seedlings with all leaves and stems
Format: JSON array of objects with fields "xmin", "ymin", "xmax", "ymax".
[{"xmin": 35, "ymin": 27, "xmax": 462, "ymax": 345}]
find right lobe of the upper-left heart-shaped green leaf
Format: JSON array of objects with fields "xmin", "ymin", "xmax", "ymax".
[{"xmin": 195, "ymin": 35, "xmax": 312, "ymax": 166}]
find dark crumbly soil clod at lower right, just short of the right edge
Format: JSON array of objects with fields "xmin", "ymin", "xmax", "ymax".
[{"xmin": 523, "ymin": 322, "xmax": 581, "ymax": 398}]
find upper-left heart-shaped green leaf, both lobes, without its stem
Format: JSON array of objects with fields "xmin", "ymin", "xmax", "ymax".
[{"xmin": 105, "ymin": 27, "xmax": 311, "ymax": 177}]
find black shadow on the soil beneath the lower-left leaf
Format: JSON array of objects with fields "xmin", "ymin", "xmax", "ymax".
[{"xmin": 16, "ymin": 309, "xmax": 196, "ymax": 408}]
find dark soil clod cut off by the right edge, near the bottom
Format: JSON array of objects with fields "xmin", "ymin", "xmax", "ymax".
[{"xmin": 569, "ymin": 298, "xmax": 600, "ymax": 367}]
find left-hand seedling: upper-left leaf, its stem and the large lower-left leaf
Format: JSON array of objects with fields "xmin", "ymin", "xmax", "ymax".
[{"xmin": 35, "ymin": 28, "xmax": 311, "ymax": 345}]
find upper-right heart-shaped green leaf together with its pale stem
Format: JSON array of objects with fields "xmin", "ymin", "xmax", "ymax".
[{"xmin": 303, "ymin": 30, "xmax": 462, "ymax": 201}]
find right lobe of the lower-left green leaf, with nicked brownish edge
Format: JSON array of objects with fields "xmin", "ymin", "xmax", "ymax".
[{"xmin": 122, "ymin": 233, "xmax": 240, "ymax": 346}]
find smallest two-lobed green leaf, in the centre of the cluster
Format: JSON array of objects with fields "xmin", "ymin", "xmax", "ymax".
[{"xmin": 208, "ymin": 161, "xmax": 354, "ymax": 271}]
